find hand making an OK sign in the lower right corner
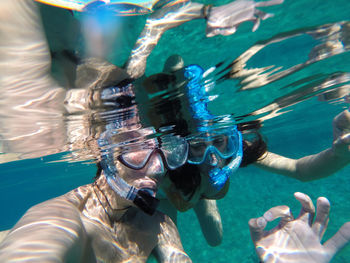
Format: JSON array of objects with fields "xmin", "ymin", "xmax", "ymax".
[{"xmin": 249, "ymin": 193, "xmax": 350, "ymax": 263}]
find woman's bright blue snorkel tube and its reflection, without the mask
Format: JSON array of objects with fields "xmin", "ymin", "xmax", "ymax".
[{"xmin": 184, "ymin": 65, "xmax": 243, "ymax": 191}]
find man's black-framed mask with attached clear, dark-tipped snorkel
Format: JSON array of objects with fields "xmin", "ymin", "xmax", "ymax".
[{"xmin": 98, "ymin": 130, "xmax": 188, "ymax": 215}]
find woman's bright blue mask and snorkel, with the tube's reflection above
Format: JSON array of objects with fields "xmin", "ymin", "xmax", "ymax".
[{"xmin": 184, "ymin": 65, "xmax": 243, "ymax": 191}]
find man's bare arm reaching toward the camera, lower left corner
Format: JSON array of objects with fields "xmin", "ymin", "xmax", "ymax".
[{"xmin": 0, "ymin": 197, "xmax": 96, "ymax": 262}]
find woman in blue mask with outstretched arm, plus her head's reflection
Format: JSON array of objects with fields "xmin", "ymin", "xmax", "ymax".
[{"xmin": 145, "ymin": 55, "xmax": 350, "ymax": 250}]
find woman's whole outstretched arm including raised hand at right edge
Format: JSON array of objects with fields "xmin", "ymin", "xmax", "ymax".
[{"xmin": 255, "ymin": 110, "xmax": 350, "ymax": 181}]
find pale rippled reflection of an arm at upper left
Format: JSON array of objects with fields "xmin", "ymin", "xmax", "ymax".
[{"xmin": 0, "ymin": 0, "xmax": 66, "ymax": 162}]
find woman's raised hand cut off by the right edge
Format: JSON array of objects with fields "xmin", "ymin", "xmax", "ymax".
[{"xmin": 332, "ymin": 110, "xmax": 350, "ymax": 158}]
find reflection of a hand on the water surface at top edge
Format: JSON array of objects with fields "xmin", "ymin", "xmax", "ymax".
[{"xmin": 206, "ymin": 0, "xmax": 283, "ymax": 37}]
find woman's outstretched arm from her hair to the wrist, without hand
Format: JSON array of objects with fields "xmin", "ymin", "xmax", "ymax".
[{"xmin": 255, "ymin": 148, "xmax": 349, "ymax": 181}]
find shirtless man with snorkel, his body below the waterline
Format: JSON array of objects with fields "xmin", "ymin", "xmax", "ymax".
[{"xmin": 0, "ymin": 130, "xmax": 191, "ymax": 262}]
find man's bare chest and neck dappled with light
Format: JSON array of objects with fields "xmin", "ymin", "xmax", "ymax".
[{"xmin": 64, "ymin": 178, "xmax": 167, "ymax": 262}]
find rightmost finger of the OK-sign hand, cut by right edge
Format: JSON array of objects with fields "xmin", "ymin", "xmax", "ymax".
[{"xmin": 324, "ymin": 222, "xmax": 350, "ymax": 257}]
